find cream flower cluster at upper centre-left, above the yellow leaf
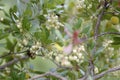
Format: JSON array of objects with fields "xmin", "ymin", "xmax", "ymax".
[{"xmin": 44, "ymin": 13, "xmax": 64, "ymax": 30}]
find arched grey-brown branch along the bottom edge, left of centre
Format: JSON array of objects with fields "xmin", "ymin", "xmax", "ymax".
[{"xmin": 29, "ymin": 72, "xmax": 67, "ymax": 80}]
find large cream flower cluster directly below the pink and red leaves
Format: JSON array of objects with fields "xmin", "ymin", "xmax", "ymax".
[{"xmin": 47, "ymin": 45, "xmax": 85, "ymax": 66}]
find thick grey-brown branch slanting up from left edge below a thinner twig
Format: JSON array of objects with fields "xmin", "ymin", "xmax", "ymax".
[{"xmin": 0, "ymin": 56, "xmax": 28, "ymax": 70}]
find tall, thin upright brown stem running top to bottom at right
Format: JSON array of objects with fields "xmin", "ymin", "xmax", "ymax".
[{"xmin": 88, "ymin": 0, "xmax": 108, "ymax": 77}]
